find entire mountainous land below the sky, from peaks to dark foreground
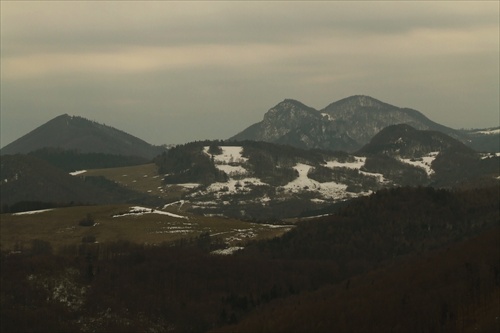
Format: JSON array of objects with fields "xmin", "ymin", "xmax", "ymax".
[{"xmin": 0, "ymin": 96, "xmax": 500, "ymax": 332}]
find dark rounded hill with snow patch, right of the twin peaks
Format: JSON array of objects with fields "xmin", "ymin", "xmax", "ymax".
[{"xmin": 357, "ymin": 124, "xmax": 500, "ymax": 187}]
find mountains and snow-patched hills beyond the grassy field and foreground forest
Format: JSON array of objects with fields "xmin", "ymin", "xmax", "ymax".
[{"xmin": 0, "ymin": 96, "xmax": 500, "ymax": 219}]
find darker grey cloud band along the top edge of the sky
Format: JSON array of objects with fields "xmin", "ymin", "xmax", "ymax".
[{"xmin": 2, "ymin": 2, "xmax": 498, "ymax": 52}]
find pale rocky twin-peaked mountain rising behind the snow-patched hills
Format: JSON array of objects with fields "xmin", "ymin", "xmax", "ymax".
[{"xmin": 230, "ymin": 96, "xmax": 464, "ymax": 151}]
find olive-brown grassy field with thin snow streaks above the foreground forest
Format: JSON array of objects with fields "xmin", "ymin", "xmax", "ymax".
[{"xmin": 0, "ymin": 205, "xmax": 290, "ymax": 251}]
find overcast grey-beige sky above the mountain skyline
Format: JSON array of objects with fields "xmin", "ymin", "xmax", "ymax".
[{"xmin": 0, "ymin": 0, "xmax": 500, "ymax": 147}]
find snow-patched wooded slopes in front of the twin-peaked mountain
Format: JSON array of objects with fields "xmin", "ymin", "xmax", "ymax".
[{"xmin": 155, "ymin": 134, "xmax": 500, "ymax": 219}]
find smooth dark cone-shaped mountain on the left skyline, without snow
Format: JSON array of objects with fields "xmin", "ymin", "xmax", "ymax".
[{"xmin": 0, "ymin": 114, "xmax": 162, "ymax": 159}]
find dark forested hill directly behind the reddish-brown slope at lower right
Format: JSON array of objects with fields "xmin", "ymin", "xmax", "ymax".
[{"xmin": 247, "ymin": 187, "xmax": 500, "ymax": 275}]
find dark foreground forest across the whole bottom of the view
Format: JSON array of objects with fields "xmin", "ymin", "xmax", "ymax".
[{"xmin": 0, "ymin": 187, "xmax": 500, "ymax": 332}]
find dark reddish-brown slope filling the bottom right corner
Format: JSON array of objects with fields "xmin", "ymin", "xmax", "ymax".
[{"xmin": 219, "ymin": 227, "xmax": 500, "ymax": 333}]
